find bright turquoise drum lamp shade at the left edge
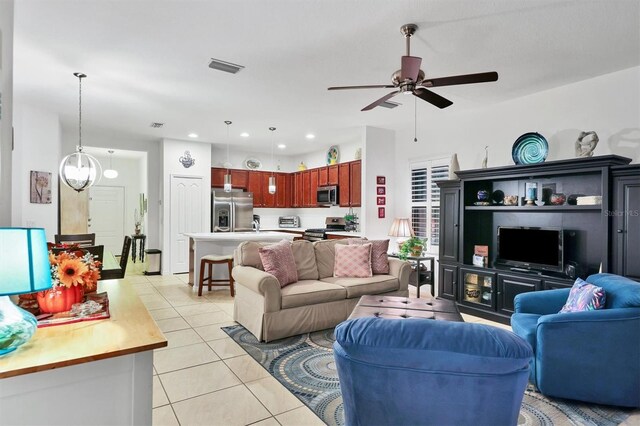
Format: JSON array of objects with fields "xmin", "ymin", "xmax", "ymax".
[{"xmin": 0, "ymin": 228, "xmax": 51, "ymax": 296}]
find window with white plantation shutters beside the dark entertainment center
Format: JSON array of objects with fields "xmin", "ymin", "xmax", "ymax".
[{"xmin": 411, "ymin": 158, "xmax": 449, "ymax": 251}]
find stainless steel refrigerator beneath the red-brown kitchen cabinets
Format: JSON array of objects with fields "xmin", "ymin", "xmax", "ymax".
[{"xmin": 211, "ymin": 190, "xmax": 253, "ymax": 232}]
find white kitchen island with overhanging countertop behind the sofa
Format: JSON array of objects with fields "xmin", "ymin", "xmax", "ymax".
[{"xmin": 184, "ymin": 231, "xmax": 295, "ymax": 288}]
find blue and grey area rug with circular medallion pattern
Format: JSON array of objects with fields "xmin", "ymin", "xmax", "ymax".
[{"xmin": 222, "ymin": 325, "xmax": 632, "ymax": 426}]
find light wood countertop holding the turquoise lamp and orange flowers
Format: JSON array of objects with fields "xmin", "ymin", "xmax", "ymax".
[{"xmin": 0, "ymin": 280, "xmax": 167, "ymax": 379}]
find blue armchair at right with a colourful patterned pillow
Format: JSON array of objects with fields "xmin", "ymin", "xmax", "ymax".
[{"xmin": 511, "ymin": 274, "xmax": 640, "ymax": 407}]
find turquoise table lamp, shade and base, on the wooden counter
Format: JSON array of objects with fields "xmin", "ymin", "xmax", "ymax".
[{"xmin": 0, "ymin": 228, "xmax": 51, "ymax": 356}]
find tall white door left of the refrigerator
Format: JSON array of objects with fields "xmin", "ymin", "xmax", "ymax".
[{"xmin": 170, "ymin": 176, "xmax": 204, "ymax": 274}]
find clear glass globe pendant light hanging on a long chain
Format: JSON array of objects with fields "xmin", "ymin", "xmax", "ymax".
[{"xmin": 59, "ymin": 72, "xmax": 101, "ymax": 192}]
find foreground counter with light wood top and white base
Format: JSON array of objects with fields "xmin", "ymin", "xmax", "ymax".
[{"xmin": 0, "ymin": 280, "xmax": 167, "ymax": 424}]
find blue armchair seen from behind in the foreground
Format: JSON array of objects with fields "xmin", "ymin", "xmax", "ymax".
[{"xmin": 333, "ymin": 317, "xmax": 532, "ymax": 426}]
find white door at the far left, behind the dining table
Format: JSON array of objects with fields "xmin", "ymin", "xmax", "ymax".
[{"xmin": 87, "ymin": 186, "xmax": 124, "ymax": 255}]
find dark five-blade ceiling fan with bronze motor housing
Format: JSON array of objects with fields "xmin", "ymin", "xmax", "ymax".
[{"xmin": 329, "ymin": 24, "xmax": 498, "ymax": 111}]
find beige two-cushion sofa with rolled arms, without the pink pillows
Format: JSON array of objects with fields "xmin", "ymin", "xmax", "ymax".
[{"xmin": 233, "ymin": 240, "xmax": 411, "ymax": 342}]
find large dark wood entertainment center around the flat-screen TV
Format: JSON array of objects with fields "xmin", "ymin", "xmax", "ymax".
[{"xmin": 438, "ymin": 155, "xmax": 640, "ymax": 324}]
